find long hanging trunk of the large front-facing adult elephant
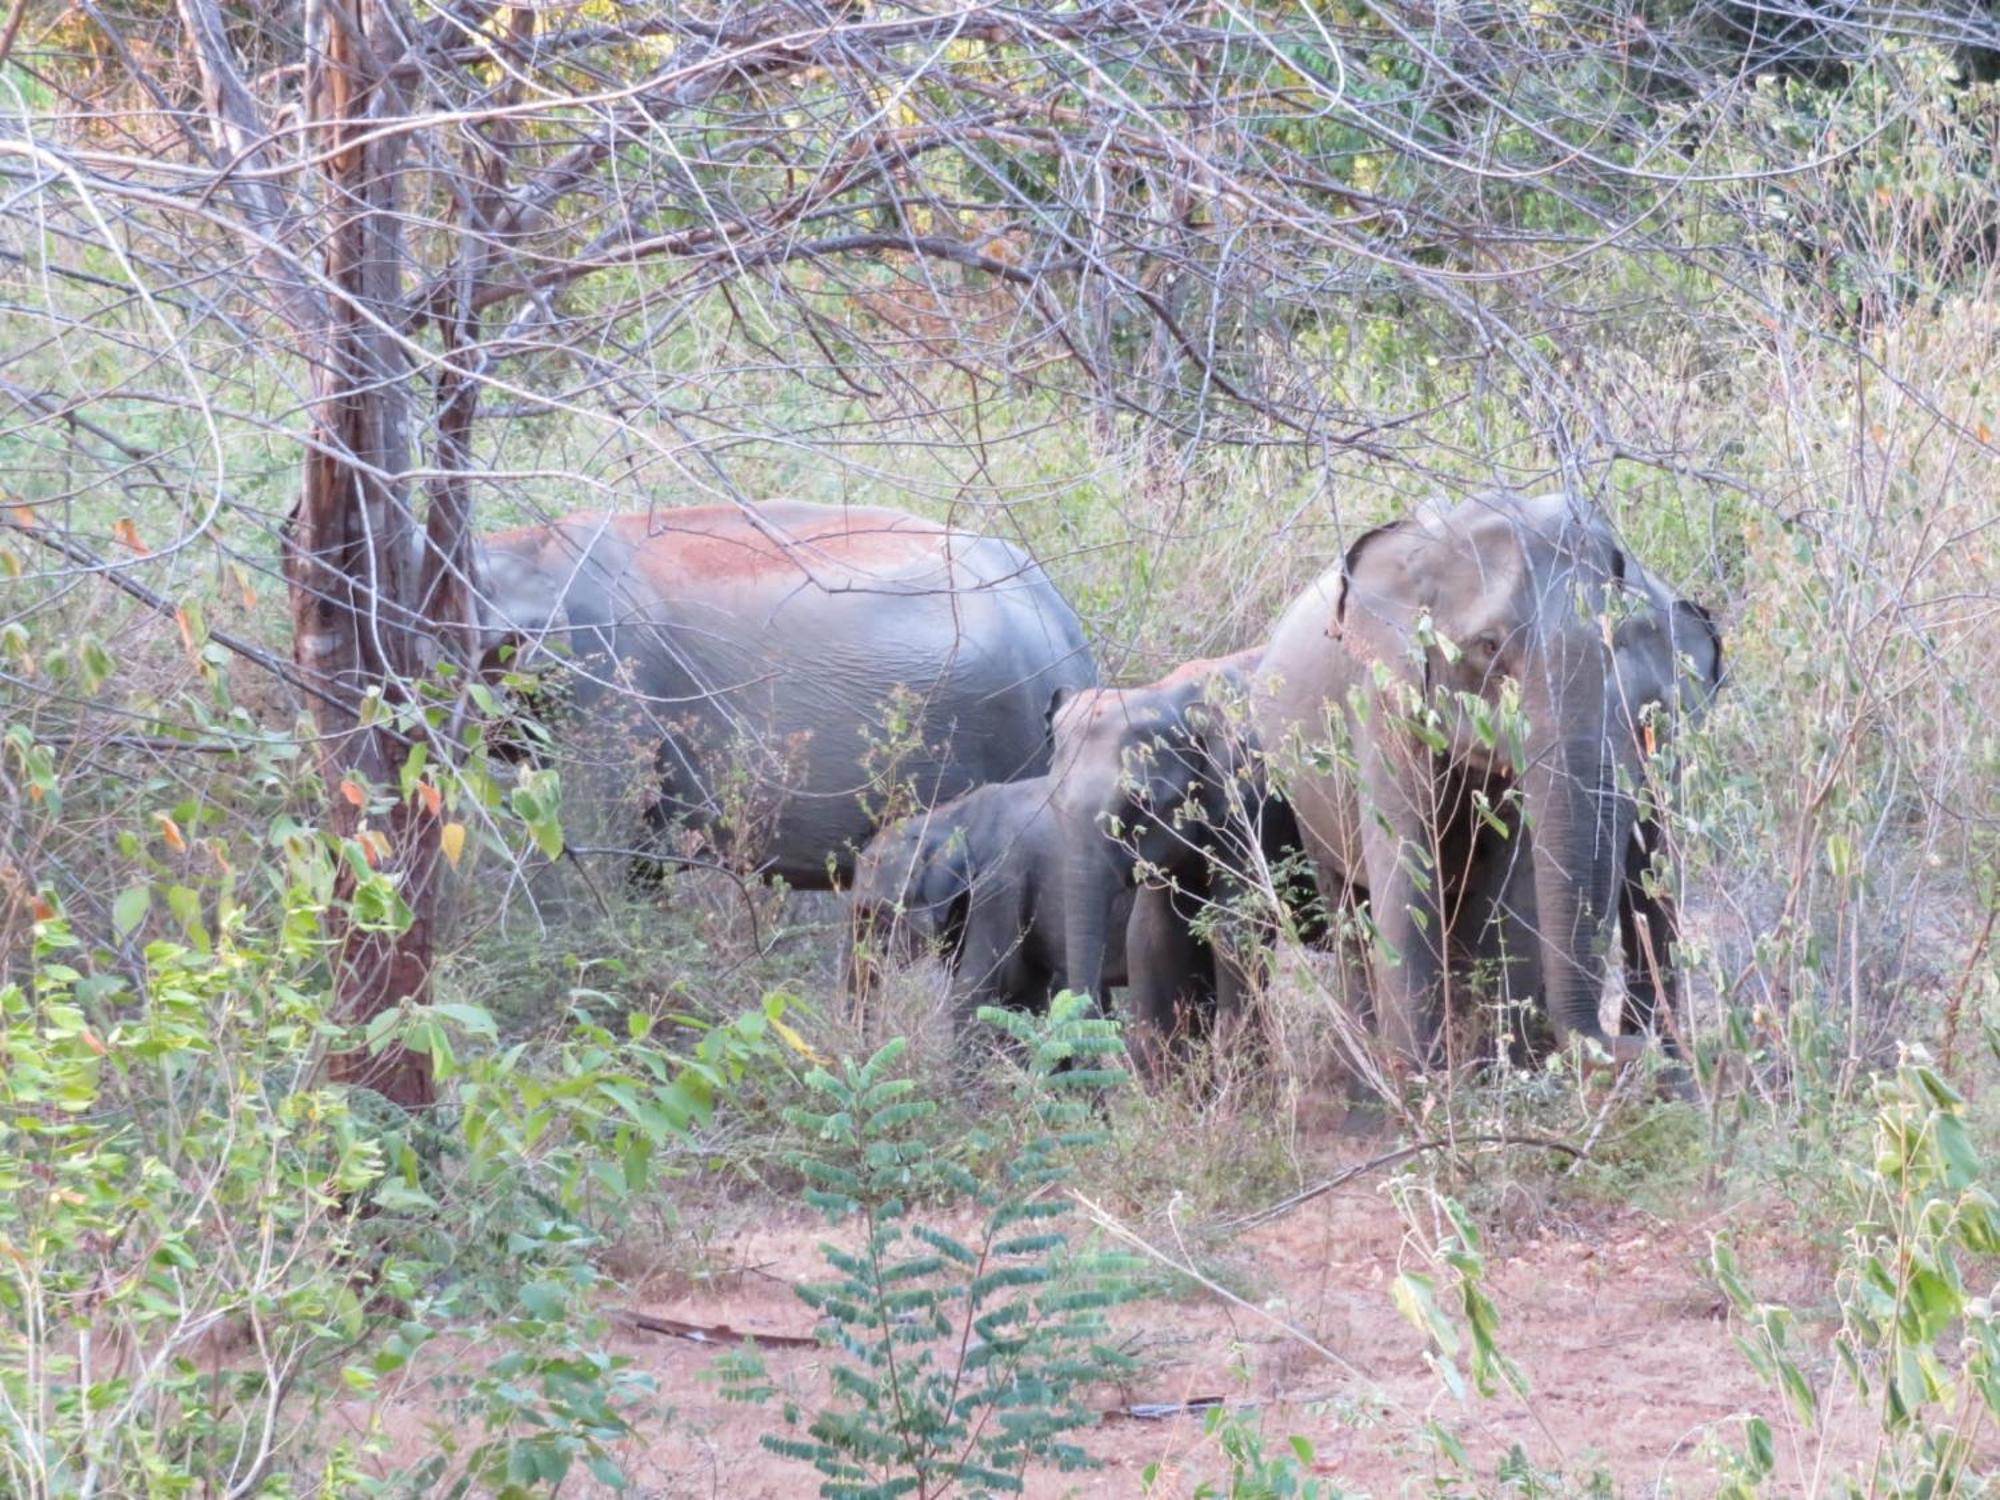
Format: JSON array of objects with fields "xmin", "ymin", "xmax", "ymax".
[{"xmin": 1524, "ymin": 730, "xmax": 1632, "ymax": 1050}]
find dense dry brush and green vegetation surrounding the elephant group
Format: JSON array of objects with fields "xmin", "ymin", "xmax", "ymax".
[{"xmin": 0, "ymin": 0, "xmax": 2000, "ymax": 1498}]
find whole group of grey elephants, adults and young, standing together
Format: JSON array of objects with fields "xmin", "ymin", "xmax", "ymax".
[{"xmin": 476, "ymin": 494, "xmax": 1722, "ymax": 1076}]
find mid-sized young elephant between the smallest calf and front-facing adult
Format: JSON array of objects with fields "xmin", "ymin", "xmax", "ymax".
[{"xmin": 1050, "ymin": 650, "xmax": 1298, "ymax": 1078}]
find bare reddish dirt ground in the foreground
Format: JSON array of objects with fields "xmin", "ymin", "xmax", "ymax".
[{"xmin": 336, "ymin": 1104, "xmax": 1862, "ymax": 1500}]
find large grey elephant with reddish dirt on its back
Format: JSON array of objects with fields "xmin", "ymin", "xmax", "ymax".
[{"xmin": 478, "ymin": 500, "xmax": 1096, "ymax": 890}]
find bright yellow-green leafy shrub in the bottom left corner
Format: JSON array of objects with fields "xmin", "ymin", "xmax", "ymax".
[{"xmin": 0, "ymin": 914, "xmax": 378, "ymax": 1496}]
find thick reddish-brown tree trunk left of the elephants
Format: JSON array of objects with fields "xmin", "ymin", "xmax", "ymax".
[{"xmin": 284, "ymin": 0, "xmax": 428, "ymax": 1108}]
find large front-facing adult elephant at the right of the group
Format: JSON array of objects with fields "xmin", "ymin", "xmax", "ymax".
[{"xmin": 1252, "ymin": 494, "xmax": 1722, "ymax": 1068}]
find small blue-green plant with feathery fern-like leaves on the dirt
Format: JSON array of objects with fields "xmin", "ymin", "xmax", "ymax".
[{"xmin": 730, "ymin": 994, "xmax": 1138, "ymax": 1500}]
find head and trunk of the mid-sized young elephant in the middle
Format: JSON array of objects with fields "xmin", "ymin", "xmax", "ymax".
[{"xmin": 1050, "ymin": 652, "xmax": 1254, "ymax": 1000}]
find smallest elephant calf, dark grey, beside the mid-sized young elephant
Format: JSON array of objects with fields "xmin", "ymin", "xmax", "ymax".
[{"xmin": 850, "ymin": 776, "xmax": 1132, "ymax": 1036}]
